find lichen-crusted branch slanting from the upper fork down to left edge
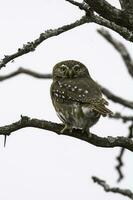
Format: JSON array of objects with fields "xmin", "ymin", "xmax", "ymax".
[{"xmin": 0, "ymin": 16, "xmax": 89, "ymax": 69}]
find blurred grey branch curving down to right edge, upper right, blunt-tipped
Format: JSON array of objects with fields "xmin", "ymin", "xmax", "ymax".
[{"xmin": 97, "ymin": 28, "xmax": 133, "ymax": 77}]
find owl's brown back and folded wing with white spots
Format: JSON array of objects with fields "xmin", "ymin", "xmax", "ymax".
[{"xmin": 52, "ymin": 78, "xmax": 112, "ymax": 116}]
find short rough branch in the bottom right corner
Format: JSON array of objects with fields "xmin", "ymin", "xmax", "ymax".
[{"xmin": 92, "ymin": 176, "xmax": 133, "ymax": 199}]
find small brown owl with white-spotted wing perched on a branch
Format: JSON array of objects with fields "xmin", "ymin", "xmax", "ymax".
[{"xmin": 51, "ymin": 60, "xmax": 112, "ymax": 133}]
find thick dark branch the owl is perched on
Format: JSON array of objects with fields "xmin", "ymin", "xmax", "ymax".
[{"xmin": 0, "ymin": 116, "xmax": 133, "ymax": 151}]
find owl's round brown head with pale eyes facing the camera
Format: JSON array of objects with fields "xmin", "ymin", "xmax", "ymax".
[{"xmin": 53, "ymin": 60, "xmax": 90, "ymax": 80}]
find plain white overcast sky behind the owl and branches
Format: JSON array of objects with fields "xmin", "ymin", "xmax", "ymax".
[{"xmin": 0, "ymin": 0, "xmax": 133, "ymax": 200}]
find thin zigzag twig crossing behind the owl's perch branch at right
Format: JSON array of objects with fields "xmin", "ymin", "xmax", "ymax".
[{"xmin": 116, "ymin": 124, "xmax": 133, "ymax": 182}]
